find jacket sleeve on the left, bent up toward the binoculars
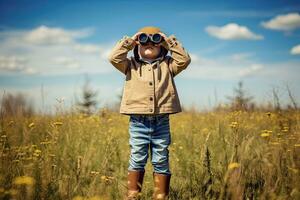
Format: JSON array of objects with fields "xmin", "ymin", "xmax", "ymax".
[{"xmin": 108, "ymin": 36, "xmax": 134, "ymax": 74}]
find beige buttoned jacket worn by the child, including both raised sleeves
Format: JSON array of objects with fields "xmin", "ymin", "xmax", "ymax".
[{"xmin": 109, "ymin": 35, "xmax": 191, "ymax": 114}]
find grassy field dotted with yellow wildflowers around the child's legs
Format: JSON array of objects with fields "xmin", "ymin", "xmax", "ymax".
[{"xmin": 0, "ymin": 110, "xmax": 300, "ymax": 200}]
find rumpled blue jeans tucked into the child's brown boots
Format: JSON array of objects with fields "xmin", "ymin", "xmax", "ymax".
[{"xmin": 128, "ymin": 113, "xmax": 171, "ymax": 174}]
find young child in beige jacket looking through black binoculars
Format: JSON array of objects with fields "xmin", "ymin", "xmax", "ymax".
[{"xmin": 109, "ymin": 26, "xmax": 191, "ymax": 199}]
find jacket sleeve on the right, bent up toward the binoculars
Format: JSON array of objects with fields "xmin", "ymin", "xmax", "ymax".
[{"xmin": 166, "ymin": 35, "xmax": 191, "ymax": 76}]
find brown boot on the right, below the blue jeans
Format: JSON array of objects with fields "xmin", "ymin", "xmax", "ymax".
[{"xmin": 152, "ymin": 172, "xmax": 171, "ymax": 200}]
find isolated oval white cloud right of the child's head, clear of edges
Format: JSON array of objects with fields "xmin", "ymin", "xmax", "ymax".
[{"xmin": 205, "ymin": 23, "xmax": 263, "ymax": 40}]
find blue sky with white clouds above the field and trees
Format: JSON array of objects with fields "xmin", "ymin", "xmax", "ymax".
[{"xmin": 0, "ymin": 0, "xmax": 300, "ymax": 110}]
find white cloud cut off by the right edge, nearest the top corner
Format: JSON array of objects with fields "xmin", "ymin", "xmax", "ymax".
[{"xmin": 261, "ymin": 13, "xmax": 300, "ymax": 31}]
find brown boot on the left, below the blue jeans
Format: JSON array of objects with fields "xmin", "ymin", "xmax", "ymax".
[{"xmin": 125, "ymin": 170, "xmax": 145, "ymax": 200}]
